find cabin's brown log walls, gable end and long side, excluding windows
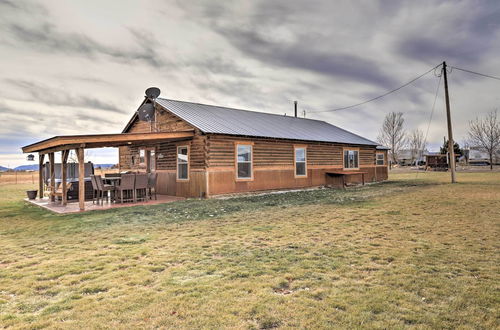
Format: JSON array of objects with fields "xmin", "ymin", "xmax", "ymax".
[{"xmin": 119, "ymin": 107, "xmax": 387, "ymax": 197}]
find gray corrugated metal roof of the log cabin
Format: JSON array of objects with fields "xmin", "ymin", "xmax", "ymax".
[{"xmin": 156, "ymin": 98, "xmax": 378, "ymax": 145}]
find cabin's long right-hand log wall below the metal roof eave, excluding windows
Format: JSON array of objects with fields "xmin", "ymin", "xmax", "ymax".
[{"xmin": 207, "ymin": 135, "xmax": 387, "ymax": 195}]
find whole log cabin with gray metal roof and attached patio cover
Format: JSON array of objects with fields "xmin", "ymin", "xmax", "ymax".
[{"xmin": 22, "ymin": 93, "xmax": 388, "ymax": 210}]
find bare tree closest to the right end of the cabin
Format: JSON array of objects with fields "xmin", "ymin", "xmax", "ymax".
[{"xmin": 377, "ymin": 112, "xmax": 406, "ymax": 164}]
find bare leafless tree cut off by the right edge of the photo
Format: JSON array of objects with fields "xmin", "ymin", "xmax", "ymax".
[{"xmin": 469, "ymin": 110, "xmax": 500, "ymax": 170}]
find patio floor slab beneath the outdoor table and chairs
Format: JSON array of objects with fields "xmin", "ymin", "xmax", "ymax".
[{"xmin": 24, "ymin": 195, "xmax": 185, "ymax": 214}]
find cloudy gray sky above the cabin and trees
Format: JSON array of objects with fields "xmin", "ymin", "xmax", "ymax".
[{"xmin": 0, "ymin": 0, "xmax": 500, "ymax": 167}]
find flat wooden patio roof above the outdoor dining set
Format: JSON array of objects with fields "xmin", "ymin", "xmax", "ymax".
[{"xmin": 22, "ymin": 130, "xmax": 194, "ymax": 154}]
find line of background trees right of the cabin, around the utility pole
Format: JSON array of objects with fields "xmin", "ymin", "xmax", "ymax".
[{"xmin": 377, "ymin": 110, "xmax": 500, "ymax": 169}]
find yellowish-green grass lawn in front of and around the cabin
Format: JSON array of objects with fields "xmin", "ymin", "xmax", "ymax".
[{"xmin": 0, "ymin": 172, "xmax": 500, "ymax": 329}]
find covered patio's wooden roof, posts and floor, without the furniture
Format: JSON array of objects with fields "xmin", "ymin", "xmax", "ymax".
[{"xmin": 22, "ymin": 130, "xmax": 194, "ymax": 213}]
